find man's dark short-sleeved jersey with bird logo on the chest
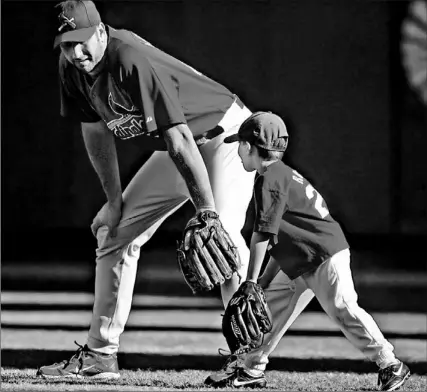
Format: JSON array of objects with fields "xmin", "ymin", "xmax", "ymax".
[{"xmin": 59, "ymin": 26, "xmax": 235, "ymax": 149}]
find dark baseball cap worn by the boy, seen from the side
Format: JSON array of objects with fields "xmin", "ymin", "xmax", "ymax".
[{"xmin": 224, "ymin": 112, "xmax": 289, "ymax": 151}]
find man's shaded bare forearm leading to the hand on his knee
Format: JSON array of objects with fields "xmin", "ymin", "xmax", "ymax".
[{"xmin": 82, "ymin": 122, "xmax": 122, "ymax": 204}]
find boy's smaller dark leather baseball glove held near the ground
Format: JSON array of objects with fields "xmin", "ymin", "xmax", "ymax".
[{"xmin": 222, "ymin": 281, "xmax": 273, "ymax": 353}]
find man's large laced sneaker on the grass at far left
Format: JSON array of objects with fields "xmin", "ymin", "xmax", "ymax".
[{"xmin": 36, "ymin": 342, "xmax": 120, "ymax": 379}]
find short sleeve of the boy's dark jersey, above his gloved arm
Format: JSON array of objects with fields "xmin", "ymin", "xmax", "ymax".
[{"xmin": 254, "ymin": 176, "xmax": 287, "ymax": 235}]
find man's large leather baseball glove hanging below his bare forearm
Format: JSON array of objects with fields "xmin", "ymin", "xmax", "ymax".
[{"xmin": 177, "ymin": 211, "xmax": 241, "ymax": 294}]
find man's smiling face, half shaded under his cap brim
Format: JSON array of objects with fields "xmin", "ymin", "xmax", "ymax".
[{"xmin": 60, "ymin": 28, "xmax": 106, "ymax": 73}]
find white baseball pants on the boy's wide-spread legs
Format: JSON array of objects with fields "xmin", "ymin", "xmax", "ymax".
[{"xmin": 244, "ymin": 249, "xmax": 396, "ymax": 375}]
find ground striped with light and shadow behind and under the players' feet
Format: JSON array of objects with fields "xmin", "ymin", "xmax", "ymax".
[{"xmin": 1, "ymin": 292, "xmax": 427, "ymax": 391}]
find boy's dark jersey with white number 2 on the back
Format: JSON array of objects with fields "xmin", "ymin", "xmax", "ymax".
[{"xmin": 254, "ymin": 161, "xmax": 348, "ymax": 279}]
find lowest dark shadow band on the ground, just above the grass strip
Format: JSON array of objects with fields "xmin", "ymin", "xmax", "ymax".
[{"xmin": 1, "ymin": 350, "xmax": 427, "ymax": 375}]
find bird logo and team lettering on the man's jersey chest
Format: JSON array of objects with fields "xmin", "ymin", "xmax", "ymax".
[{"xmin": 107, "ymin": 92, "xmax": 153, "ymax": 139}]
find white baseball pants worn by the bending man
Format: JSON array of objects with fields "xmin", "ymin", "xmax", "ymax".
[{"xmin": 87, "ymin": 99, "xmax": 255, "ymax": 354}]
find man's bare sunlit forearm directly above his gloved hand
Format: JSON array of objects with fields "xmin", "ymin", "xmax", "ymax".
[{"xmin": 164, "ymin": 124, "xmax": 215, "ymax": 210}]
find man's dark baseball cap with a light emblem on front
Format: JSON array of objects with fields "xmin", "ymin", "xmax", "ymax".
[{"xmin": 53, "ymin": 0, "xmax": 101, "ymax": 48}]
